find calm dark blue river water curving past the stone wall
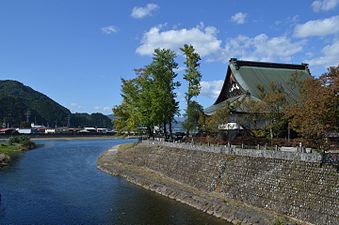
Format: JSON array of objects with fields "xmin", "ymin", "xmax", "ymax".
[{"xmin": 0, "ymin": 139, "xmax": 230, "ymax": 225}]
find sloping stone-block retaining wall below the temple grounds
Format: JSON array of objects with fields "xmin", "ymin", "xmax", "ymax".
[{"xmin": 112, "ymin": 143, "xmax": 339, "ymax": 225}]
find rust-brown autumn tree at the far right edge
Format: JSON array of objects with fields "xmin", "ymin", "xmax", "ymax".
[{"xmin": 286, "ymin": 66, "xmax": 339, "ymax": 146}]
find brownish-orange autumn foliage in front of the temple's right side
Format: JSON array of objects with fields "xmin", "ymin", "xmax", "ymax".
[{"xmin": 243, "ymin": 66, "xmax": 339, "ymax": 147}]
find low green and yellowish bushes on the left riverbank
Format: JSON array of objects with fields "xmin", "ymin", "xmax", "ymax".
[{"xmin": 0, "ymin": 136, "xmax": 36, "ymax": 167}]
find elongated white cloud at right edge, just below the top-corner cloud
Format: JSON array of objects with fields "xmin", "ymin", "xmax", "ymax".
[{"xmin": 294, "ymin": 16, "xmax": 339, "ymax": 38}]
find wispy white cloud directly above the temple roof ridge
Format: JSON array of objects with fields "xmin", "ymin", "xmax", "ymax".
[{"xmin": 216, "ymin": 34, "xmax": 304, "ymax": 62}]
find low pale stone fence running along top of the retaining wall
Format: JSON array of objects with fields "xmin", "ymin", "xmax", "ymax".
[{"xmin": 143, "ymin": 140, "xmax": 322, "ymax": 163}]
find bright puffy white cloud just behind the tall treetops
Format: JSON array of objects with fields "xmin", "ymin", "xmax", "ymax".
[{"xmin": 136, "ymin": 24, "xmax": 221, "ymax": 56}]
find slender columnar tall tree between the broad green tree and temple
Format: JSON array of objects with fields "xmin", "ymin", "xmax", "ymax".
[{"xmin": 180, "ymin": 44, "xmax": 201, "ymax": 134}]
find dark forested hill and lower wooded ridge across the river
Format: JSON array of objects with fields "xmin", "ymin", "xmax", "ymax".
[{"xmin": 0, "ymin": 80, "xmax": 112, "ymax": 127}]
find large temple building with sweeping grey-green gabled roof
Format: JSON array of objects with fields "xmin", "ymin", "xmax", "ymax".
[{"xmin": 204, "ymin": 58, "xmax": 311, "ymax": 130}]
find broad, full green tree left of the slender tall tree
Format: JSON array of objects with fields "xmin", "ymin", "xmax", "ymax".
[{"xmin": 113, "ymin": 49, "xmax": 180, "ymax": 134}]
